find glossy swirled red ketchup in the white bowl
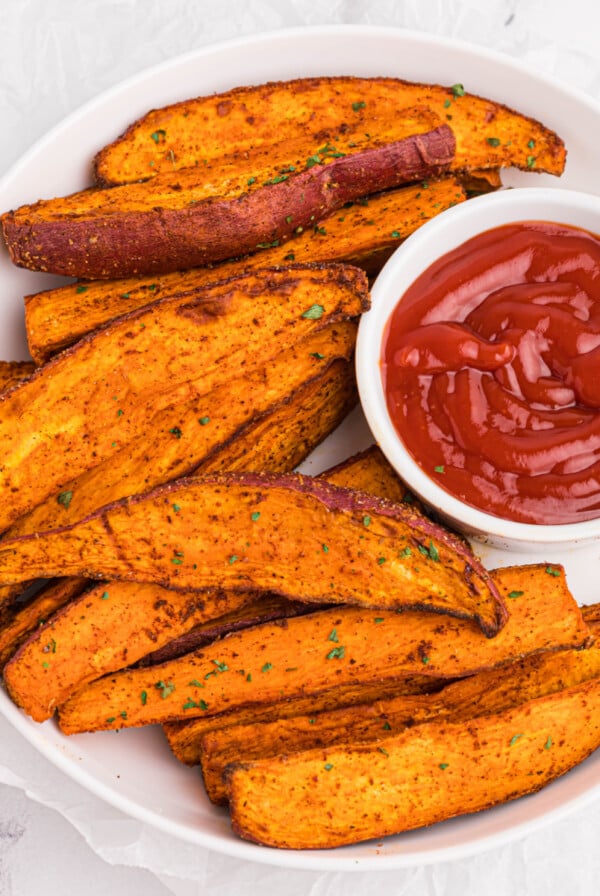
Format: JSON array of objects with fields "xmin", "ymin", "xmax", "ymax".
[{"xmin": 382, "ymin": 221, "xmax": 600, "ymax": 524}]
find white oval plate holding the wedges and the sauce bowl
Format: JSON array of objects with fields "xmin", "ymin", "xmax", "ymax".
[{"xmin": 0, "ymin": 26, "xmax": 600, "ymax": 871}]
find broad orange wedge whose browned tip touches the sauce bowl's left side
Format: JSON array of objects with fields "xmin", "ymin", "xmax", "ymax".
[{"xmin": 0, "ymin": 265, "xmax": 368, "ymax": 531}]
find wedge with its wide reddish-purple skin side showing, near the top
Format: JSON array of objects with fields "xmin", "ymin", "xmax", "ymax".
[{"xmin": 2, "ymin": 109, "xmax": 455, "ymax": 279}]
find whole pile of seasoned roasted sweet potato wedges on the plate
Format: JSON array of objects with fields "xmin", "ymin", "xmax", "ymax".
[{"xmin": 0, "ymin": 77, "xmax": 600, "ymax": 849}]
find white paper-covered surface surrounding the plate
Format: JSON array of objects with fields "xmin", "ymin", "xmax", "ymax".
[{"xmin": 0, "ymin": 0, "xmax": 600, "ymax": 896}]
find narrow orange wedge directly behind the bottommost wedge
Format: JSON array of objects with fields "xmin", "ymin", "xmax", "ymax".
[{"xmin": 199, "ymin": 612, "xmax": 600, "ymax": 804}]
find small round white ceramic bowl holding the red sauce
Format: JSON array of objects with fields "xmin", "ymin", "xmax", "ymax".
[{"xmin": 356, "ymin": 188, "xmax": 600, "ymax": 551}]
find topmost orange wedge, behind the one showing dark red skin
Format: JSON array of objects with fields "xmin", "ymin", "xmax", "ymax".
[{"xmin": 95, "ymin": 76, "xmax": 564, "ymax": 185}]
